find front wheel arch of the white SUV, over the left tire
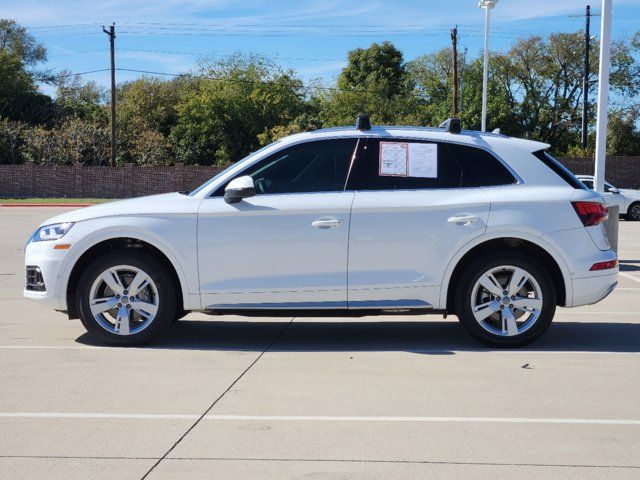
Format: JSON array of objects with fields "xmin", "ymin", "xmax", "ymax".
[{"xmin": 60, "ymin": 232, "xmax": 189, "ymax": 319}]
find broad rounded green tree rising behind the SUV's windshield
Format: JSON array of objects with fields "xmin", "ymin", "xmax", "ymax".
[{"xmin": 170, "ymin": 55, "xmax": 303, "ymax": 165}]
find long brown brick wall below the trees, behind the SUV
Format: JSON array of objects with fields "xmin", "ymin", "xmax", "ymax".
[{"xmin": 0, "ymin": 156, "xmax": 640, "ymax": 198}]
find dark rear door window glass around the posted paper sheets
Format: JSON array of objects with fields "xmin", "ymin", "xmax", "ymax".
[{"xmin": 347, "ymin": 139, "xmax": 476, "ymax": 190}]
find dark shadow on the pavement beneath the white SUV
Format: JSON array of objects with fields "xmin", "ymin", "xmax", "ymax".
[{"xmin": 77, "ymin": 319, "xmax": 640, "ymax": 355}]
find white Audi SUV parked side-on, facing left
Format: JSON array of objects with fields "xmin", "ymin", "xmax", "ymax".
[{"xmin": 24, "ymin": 117, "xmax": 618, "ymax": 346}]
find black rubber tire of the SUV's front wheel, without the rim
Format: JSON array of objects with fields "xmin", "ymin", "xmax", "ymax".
[{"xmin": 76, "ymin": 250, "xmax": 178, "ymax": 346}]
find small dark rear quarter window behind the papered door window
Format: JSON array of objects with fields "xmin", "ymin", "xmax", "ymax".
[{"xmin": 449, "ymin": 144, "xmax": 518, "ymax": 187}]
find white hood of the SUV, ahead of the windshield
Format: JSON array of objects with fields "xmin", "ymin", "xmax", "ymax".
[{"xmin": 40, "ymin": 192, "xmax": 201, "ymax": 226}]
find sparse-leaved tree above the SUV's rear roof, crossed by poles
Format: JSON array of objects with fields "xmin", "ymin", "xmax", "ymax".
[{"xmin": 491, "ymin": 33, "xmax": 639, "ymax": 152}]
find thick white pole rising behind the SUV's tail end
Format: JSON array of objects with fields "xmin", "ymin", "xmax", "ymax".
[{"xmin": 593, "ymin": 0, "xmax": 611, "ymax": 193}]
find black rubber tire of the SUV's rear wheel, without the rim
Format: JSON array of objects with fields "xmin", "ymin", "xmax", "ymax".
[{"xmin": 454, "ymin": 250, "xmax": 557, "ymax": 348}]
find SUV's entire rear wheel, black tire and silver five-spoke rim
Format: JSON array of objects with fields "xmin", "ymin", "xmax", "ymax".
[{"xmin": 455, "ymin": 251, "xmax": 556, "ymax": 347}]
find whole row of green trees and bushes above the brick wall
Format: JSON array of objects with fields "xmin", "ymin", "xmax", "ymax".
[{"xmin": 0, "ymin": 19, "xmax": 640, "ymax": 165}]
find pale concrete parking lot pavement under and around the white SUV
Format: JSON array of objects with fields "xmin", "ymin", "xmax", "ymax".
[{"xmin": 0, "ymin": 208, "xmax": 640, "ymax": 480}]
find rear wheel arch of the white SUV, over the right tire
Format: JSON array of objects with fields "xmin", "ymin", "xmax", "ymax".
[{"xmin": 440, "ymin": 235, "xmax": 573, "ymax": 313}]
